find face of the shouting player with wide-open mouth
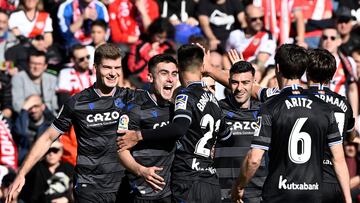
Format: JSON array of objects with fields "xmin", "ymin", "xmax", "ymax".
[{"xmin": 149, "ymin": 62, "xmax": 179, "ymax": 100}]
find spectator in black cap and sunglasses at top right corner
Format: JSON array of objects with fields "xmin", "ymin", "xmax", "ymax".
[{"xmin": 336, "ymin": 7, "xmax": 360, "ymax": 56}]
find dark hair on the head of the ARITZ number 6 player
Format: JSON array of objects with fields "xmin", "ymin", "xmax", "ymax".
[{"xmin": 275, "ymin": 44, "xmax": 309, "ymax": 79}]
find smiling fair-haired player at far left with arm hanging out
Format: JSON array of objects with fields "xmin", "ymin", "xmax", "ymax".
[{"xmin": 6, "ymin": 44, "xmax": 133, "ymax": 203}]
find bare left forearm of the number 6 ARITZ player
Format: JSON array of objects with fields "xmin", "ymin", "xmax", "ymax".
[{"xmin": 231, "ymin": 148, "xmax": 264, "ymax": 202}]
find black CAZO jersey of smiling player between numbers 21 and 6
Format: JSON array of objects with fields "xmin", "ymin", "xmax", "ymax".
[{"xmin": 214, "ymin": 96, "xmax": 267, "ymax": 202}]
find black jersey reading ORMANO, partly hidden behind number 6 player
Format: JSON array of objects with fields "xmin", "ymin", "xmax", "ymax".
[{"xmin": 309, "ymin": 85, "xmax": 355, "ymax": 183}]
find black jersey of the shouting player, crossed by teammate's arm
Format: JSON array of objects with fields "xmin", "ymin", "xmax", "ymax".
[{"xmin": 126, "ymin": 90, "xmax": 175, "ymax": 199}]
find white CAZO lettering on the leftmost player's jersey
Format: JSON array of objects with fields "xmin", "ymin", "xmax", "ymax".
[{"xmin": 86, "ymin": 111, "xmax": 120, "ymax": 127}]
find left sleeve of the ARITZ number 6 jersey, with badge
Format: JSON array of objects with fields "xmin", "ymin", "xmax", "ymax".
[{"xmin": 251, "ymin": 105, "xmax": 272, "ymax": 150}]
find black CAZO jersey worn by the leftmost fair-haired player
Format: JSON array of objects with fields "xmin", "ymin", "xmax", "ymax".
[{"xmin": 52, "ymin": 86, "xmax": 133, "ymax": 192}]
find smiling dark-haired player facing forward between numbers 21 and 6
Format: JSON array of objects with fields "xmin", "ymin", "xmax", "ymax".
[{"xmin": 214, "ymin": 61, "xmax": 267, "ymax": 203}]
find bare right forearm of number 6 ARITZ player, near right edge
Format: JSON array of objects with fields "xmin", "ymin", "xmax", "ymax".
[{"xmin": 330, "ymin": 144, "xmax": 352, "ymax": 203}]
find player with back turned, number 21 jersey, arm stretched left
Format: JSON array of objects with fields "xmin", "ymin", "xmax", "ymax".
[{"xmin": 118, "ymin": 45, "xmax": 231, "ymax": 203}]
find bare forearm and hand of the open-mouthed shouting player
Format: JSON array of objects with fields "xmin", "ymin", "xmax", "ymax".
[{"xmin": 119, "ymin": 150, "xmax": 165, "ymax": 190}]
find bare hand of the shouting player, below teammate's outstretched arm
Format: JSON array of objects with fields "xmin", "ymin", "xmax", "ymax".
[{"xmin": 140, "ymin": 166, "xmax": 165, "ymax": 191}]
